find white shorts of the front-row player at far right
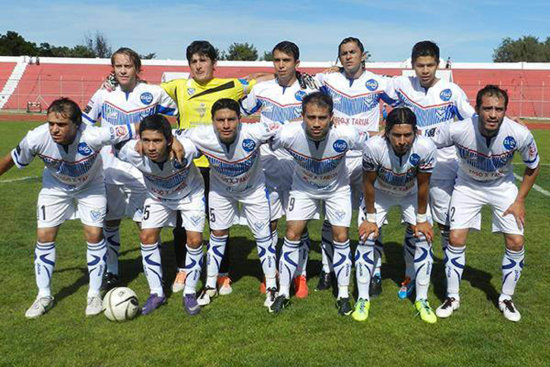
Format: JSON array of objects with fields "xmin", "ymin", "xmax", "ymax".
[{"xmin": 449, "ymin": 181, "xmax": 523, "ymax": 235}]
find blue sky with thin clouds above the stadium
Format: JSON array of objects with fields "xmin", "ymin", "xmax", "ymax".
[{"xmin": 0, "ymin": 0, "xmax": 550, "ymax": 62}]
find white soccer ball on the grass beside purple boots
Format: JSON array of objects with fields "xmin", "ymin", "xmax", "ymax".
[{"xmin": 103, "ymin": 287, "xmax": 139, "ymax": 321}]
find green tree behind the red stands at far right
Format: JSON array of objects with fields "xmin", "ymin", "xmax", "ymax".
[{"xmin": 493, "ymin": 36, "xmax": 550, "ymax": 62}]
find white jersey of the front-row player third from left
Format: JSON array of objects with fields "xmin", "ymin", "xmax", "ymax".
[{"xmin": 185, "ymin": 123, "xmax": 279, "ymax": 195}]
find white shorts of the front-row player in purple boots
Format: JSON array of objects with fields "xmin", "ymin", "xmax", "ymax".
[{"xmin": 141, "ymin": 190, "xmax": 205, "ymax": 233}]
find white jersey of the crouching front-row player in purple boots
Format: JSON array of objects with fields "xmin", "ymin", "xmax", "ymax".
[{"xmin": 118, "ymin": 136, "xmax": 204, "ymax": 201}]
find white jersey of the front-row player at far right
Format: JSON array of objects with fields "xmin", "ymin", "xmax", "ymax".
[{"xmin": 434, "ymin": 116, "xmax": 540, "ymax": 185}]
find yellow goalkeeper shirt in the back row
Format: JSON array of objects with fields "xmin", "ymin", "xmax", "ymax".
[{"xmin": 161, "ymin": 78, "xmax": 256, "ymax": 167}]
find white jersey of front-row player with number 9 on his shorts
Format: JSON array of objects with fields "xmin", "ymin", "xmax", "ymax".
[{"xmin": 273, "ymin": 122, "xmax": 369, "ymax": 195}]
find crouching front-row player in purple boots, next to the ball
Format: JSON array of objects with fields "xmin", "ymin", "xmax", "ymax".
[{"xmin": 119, "ymin": 115, "xmax": 204, "ymax": 315}]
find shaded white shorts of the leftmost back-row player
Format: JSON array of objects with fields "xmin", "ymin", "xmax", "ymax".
[{"xmin": 105, "ymin": 182, "xmax": 147, "ymax": 222}]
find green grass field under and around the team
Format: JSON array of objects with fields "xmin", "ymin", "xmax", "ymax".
[{"xmin": 0, "ymin": 122, "xmax": 550, "ymax": 366}]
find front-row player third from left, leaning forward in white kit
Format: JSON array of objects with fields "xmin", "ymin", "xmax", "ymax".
[{"xmin": 187, "ymin": 98, "xmax": 278, "ymax": 307}]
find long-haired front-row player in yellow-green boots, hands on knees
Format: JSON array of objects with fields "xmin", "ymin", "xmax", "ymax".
[{"xmin": 358, "ymin": 107, "xmax": 437, "ymax": 323}]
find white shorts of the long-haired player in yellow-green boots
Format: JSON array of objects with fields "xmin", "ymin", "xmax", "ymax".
[{"xmin": 357, "ymin": 188, "xmax": 420, "ymax": 228}]
